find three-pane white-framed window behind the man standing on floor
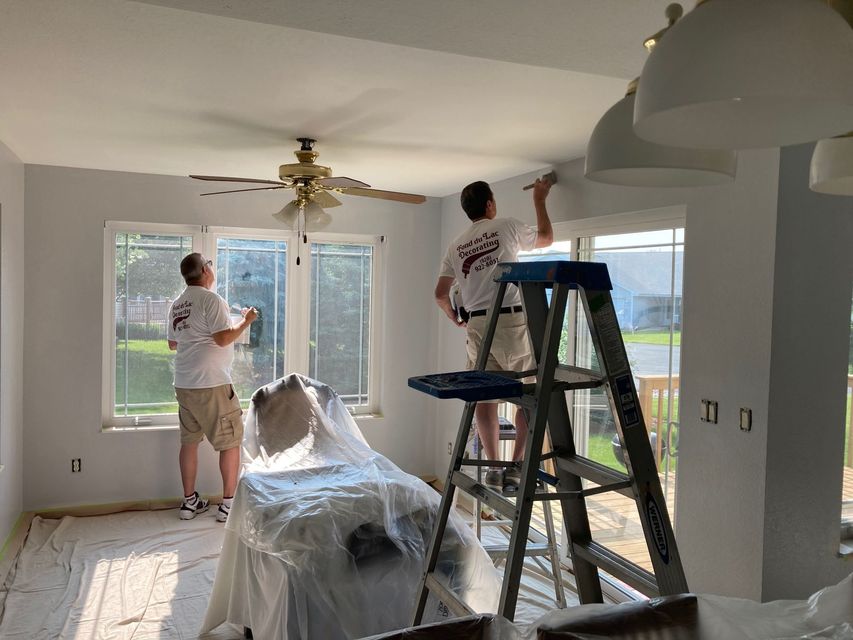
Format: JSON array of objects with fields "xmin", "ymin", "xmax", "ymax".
[{"xmin": 103, "ymin": 222, "xmax": 380, "ymax": 427}]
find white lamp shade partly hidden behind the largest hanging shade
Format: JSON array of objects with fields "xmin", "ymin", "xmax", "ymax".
[{"xmin": 585, "ymin": 94, "xmax": 737, "ymax": 187}]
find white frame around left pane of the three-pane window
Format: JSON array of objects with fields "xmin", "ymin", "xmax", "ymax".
[{"xmin": 101, "ymin": 221, "xmax": 202, "ymax": 429}]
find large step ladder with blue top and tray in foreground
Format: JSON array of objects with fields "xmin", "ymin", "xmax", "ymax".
[{"xmin": 409, "ymin": 261, "xmax": 688, "ymax": 625}]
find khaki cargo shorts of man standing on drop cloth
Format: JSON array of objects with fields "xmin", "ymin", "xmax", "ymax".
[{"xmin": 175, "ymin": 384, "xmax": 243, "ymax": 451}]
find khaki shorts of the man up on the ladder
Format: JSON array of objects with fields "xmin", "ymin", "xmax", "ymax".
[{"xmin": 465, "ymin": 311, "xmax": 536, "ymax": 402}]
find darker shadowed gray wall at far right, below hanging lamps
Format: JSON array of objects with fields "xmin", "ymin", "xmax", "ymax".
[{"xmin": 763, "ymin": 144, "xmax": 853, "ymax": 599}]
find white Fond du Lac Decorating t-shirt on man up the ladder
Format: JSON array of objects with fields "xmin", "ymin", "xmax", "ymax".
[{"xmin": 439, "ymin": 218, "xmax": 537, "ymax": 311}]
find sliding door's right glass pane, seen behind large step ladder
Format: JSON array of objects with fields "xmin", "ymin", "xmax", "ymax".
[{"xmin": 573, "ymin": 229, "xmax": 684, "ymax": 569}]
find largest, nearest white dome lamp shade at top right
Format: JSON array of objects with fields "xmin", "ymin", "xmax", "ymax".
[{"xmin": 634, "ymin": 0, "xmax": 853, "ymax": 149}]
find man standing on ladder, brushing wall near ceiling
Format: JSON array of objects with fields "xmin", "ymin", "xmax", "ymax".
[{"xmin": 435, "ymin": 180, "xmax": 554, "ymax": 493}]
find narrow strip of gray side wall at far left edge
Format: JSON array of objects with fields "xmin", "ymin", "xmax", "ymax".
[{"xmin": 0, "ymin": 143, "xmax": 24, "ymax": 545}]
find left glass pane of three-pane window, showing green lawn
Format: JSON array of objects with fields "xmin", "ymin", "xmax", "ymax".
[{"xmin": 114, "ymin": 233, "xmax": 192, "ymax": 416}]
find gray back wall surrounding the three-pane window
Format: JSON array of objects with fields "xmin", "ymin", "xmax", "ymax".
[{"xmin": 24, "ymin": 165, "xmax": 439, "ymax": 509}]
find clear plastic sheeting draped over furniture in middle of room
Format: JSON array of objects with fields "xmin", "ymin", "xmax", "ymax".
[{"xmin": 203, "ymin": 374, "xmax": 500, "ymax": 640}]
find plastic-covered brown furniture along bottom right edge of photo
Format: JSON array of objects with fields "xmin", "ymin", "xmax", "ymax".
[{"xmin": 366, "ymin": 575, "xmax": 853, "ymax": 640}]
